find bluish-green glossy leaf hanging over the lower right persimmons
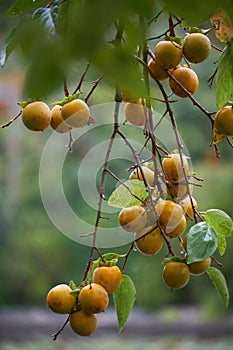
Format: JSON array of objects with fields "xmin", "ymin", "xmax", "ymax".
[{"xmin": 187, "ymin": 222, "xmax": 218, "ymax": 264}]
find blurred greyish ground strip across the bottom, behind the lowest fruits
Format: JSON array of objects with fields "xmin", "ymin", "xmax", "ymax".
[{"xmin": 0, "ymin": 307, "xmax": 233, "ymax": 344}]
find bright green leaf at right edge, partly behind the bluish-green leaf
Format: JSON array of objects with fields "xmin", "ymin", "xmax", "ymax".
[{"xmin": 202, "ymin": 209, "xmax": 233, "ymax": 255}]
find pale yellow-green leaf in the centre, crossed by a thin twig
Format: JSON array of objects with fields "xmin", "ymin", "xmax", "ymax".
[{"xmin": 108, "ymin": 180, "xmax": 148, "ymax": 208}]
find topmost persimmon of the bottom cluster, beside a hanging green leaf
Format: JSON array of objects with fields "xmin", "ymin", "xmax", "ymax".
[{"xmin": 93, "ymin": 265, "xmax": 122, "ymax": 294}]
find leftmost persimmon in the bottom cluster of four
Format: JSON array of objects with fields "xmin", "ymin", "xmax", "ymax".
[{"xmin": 46, "ymin": 284, "xmax": 76, "ymax": 314}]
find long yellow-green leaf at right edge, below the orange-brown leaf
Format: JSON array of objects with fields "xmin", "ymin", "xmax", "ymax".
[{"xmin": 216, "ymin": 43, "xmax": 233, "ymax": 109}]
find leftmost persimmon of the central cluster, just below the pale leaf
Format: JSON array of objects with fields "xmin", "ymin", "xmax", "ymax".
[{"xmin": 118, "ymin": 205, "xmax": 147, "ymax": 232}]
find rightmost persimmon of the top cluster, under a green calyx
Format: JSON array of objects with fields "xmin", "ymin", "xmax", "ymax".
[{"xmin": 183, "ymin": 33, "xmax": 211, "ymax": 63}]
